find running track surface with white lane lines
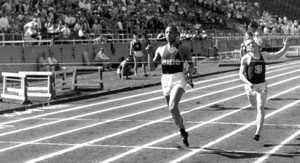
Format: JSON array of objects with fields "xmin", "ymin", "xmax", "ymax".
[{"xmin": 0, "ymin": 61, "xmax": 300, "ymax": 163}]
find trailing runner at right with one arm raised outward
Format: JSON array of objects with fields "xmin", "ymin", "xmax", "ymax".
[{"xmin": 239, "ymin": 37, "xmax": 290, "ymax": 141}]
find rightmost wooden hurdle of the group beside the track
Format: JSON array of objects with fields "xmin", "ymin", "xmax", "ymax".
[{"xmin": 62, "ymin": 66, "xmax": 104, "ymax": 91}]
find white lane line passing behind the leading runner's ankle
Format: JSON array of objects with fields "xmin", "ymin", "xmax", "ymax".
[{"xmin": 99, "ymin": 83, "xmax": 300, "ymax": 163}]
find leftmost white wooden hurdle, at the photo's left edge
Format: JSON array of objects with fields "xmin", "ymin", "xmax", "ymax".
[{"xmin": 1, "ymin": 72, "xmax": 29, "ymax": 105}]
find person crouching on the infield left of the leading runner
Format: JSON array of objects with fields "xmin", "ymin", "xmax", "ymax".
[{"xmin": 117, "ymin": 56, "xmax": 134, "ymax": 80}]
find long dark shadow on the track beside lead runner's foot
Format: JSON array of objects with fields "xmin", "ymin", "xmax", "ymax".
[{"xmin": 191, "ymin": 147, "xmax": 297, "ymax": 159}]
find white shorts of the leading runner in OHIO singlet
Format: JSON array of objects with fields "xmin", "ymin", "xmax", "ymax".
[{"xmin": 161, "ymin": 72, "xmax": 187, "ymax": 96}]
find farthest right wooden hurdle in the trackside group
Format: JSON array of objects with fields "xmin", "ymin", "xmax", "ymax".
[{"xmin": 62, "ymin": 66, "xmax": 103, "ymax": 91}]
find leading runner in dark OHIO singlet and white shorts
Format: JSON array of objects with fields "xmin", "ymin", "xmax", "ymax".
[{"xmin": 146, "ymin": 26, "xmax": 194, "ymax": 146}]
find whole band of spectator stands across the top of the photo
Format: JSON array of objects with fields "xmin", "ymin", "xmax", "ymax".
[{"xmin": 0, "ymin": 0, "xmax": 300, "ymax": 39}]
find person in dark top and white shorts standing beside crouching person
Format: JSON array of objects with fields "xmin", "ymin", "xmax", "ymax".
[{"xmin": 129, "ymin": 33, "xmax": 148, "ymax": 77}]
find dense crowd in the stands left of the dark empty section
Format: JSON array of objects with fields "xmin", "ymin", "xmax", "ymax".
[{"xmin": 0, "ymin": 0, "xmax": 232, "ymax": 38}]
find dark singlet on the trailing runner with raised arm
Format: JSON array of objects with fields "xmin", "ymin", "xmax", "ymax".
[{"xmin": 246, "ymin": 54, "xmax": 266, "ymax": 84}]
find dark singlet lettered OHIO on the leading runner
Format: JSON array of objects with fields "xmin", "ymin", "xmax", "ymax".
[{"xmin": 161, "ymin": 45, "xmax": 183, "ymax": 74}]
